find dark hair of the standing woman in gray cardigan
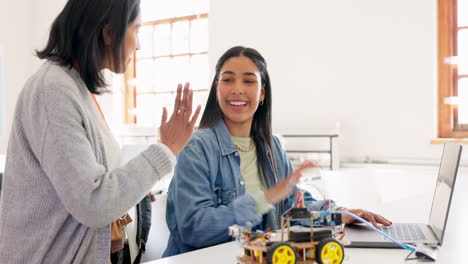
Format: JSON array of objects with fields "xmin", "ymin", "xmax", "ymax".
[{"xmin": 36, "ymin": 0, "xmax": 140, "ymax": 94}]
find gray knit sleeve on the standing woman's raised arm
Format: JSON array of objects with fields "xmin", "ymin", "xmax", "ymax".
[{"xmin": 31, "ymin": 78, "xmax": 174, "ymax": 227}]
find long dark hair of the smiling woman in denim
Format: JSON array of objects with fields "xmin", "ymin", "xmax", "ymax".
[{"xmin": 200, "ymin": 46, "xmax": 279, "ymax": 187}]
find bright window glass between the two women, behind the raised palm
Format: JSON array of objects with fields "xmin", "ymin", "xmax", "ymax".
[{"xmin": 135, "ymin": 0, "xmax": 210, "ymax": 126}]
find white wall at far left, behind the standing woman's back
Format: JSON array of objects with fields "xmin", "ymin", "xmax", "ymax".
[{"xmin": 0, "ymin": 0, "xmax": 66, "ymax": 153}]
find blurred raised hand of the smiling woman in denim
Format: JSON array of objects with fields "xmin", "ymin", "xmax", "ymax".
[{"xmin": 265, "ymin": 161, "xmax": 317, "ymax": 204}]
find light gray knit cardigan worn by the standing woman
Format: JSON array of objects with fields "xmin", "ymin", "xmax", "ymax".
[{"xmin": 0, "ymin": 62, "xmax": 175, "ymax": 264}]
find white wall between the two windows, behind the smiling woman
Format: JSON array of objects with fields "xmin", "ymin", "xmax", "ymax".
[{"xmin": 209, "ymin": 0, "xmax": 442, "ymax": 164}]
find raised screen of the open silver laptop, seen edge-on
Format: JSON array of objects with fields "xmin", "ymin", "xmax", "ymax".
[{"xmin": 429, "ymin": 143, "xmax": 462, "ymax": 244}]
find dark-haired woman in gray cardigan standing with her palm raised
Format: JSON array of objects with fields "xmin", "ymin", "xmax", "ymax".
[{"xmin": 0, "ymin": 0, "xmax": 200, "ymax": 264}]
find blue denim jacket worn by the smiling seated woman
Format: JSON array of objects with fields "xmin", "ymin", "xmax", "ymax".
[{"xmin": 163, "ymin": 121, "xmax": 330, "ymax": 257}]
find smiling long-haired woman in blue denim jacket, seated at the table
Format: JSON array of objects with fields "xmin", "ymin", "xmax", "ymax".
[{"xmin": 164, "ymin": 47, "xmax": 390, "ymax": 256}]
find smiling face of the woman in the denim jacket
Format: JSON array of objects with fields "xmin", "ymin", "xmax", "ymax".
[{"xmin": 216, "ymin": 56, "xmax": 265, "ymax": 130}]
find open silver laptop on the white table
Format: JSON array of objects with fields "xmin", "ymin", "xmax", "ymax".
[{"xmin": 345, "ymin": 143, "xmax": 462, "ymax": 248}]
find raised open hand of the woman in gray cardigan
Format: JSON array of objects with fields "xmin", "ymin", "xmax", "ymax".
[{"xmin": 160, "ymin": 83, "xmax": 201, "ymax": 155}]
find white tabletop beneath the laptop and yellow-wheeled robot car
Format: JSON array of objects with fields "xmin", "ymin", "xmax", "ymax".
[{"xmin": 144, "ymin": 166, "xmax": 468, "ymax": 264}]
